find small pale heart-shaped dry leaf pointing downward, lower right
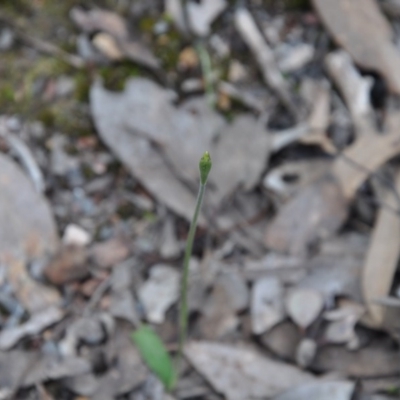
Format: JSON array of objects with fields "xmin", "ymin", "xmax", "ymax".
[{"xmin": 286, "ymin": 288, "xmax": 324, "ymax": 328}]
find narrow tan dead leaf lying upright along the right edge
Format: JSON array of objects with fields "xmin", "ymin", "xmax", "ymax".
[{"xmin": 362, "ymin": 172, "xmax": 400, "ymax": 328}]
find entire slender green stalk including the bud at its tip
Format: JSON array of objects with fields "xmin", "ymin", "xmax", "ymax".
[{"xmin": 178, "ymin": 151, "xmax": 212, "ymax": 367}]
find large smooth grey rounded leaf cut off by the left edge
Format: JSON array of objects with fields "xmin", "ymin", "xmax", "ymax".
[{"xmin": 0, "ymin": 154, "xmax": 58, "ymax": 265}]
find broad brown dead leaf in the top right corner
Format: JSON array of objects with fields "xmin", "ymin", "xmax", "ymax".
[{"xmin": 314, "ymin": 0, "xmax": 400, "ymax": 94}]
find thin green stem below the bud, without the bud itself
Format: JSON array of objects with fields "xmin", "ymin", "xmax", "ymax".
[{"xmin": 178, "ymin": 183, "xmax": 206, "ymax": 366}]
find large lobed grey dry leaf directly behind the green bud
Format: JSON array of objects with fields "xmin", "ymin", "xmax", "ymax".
[{"xmin": 91, "ymin": 78, "xmax": 269, "ymax": 223}]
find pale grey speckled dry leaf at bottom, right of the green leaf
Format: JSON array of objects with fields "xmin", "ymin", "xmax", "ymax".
[{"xmin": 185, "ymin": 342, "xmax": 315, "ymax": 400}]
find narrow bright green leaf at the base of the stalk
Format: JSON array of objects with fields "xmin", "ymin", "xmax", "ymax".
[{"xmin": 132, "ymin": 325, "xmax": 177, "ymax": 390}]
